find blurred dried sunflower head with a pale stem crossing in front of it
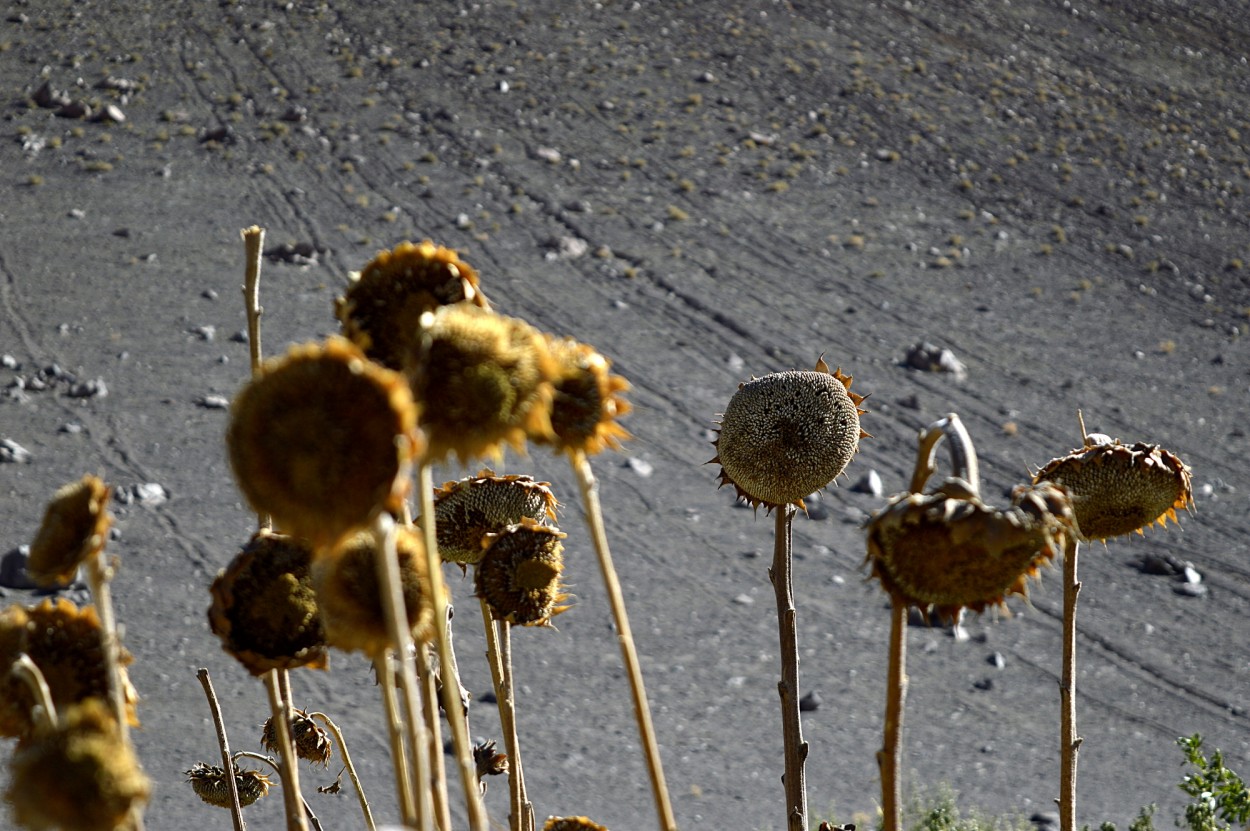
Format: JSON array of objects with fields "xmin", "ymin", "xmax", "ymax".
[{"xmin": 313, "ymin": 527, "xmax": 434, "ymax": 659}]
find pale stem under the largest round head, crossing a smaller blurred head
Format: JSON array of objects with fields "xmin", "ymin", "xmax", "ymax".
[{"xmin": 371, "ymin": 511, "xmax": 434, "ymax": 831}]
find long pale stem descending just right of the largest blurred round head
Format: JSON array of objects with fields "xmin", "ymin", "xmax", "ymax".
[{"xmin": 416, "ymin": 461, "xmax": 489, "ymax": 831}]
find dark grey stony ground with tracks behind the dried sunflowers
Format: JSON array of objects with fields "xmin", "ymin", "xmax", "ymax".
[{"xmin": 0, "ymin": 0, "xmax": 1250, "ymax": 831}]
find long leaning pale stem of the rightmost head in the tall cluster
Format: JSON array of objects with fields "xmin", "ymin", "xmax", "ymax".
[{"xmin": 569, "ymin": 450, "xmax": 680, "ymax": 831}]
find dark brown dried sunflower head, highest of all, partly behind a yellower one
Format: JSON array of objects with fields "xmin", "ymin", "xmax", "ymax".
[{"xmin": 334, "ymin": 240, "xmax": 490, "ymax": 370}]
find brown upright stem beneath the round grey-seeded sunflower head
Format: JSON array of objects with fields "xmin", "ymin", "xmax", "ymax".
[{"xmin": 769, "ymin": 505, "xmax": 808, "ymax": 831}]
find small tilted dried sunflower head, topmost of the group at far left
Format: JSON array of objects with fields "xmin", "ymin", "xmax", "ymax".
[{"xmin": 26, "ymin": 475, "xmax": 113, "ymax": 586}]
